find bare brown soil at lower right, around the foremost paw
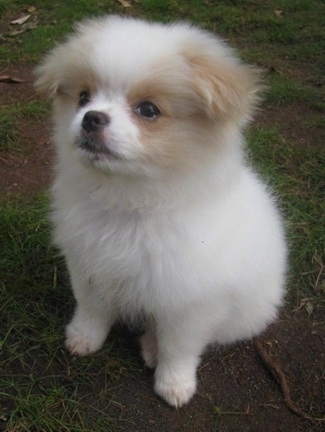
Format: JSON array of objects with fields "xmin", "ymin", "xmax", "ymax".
[{"xmin": 108, "ymin": 309, "xmax": 325, "ymax": 432}]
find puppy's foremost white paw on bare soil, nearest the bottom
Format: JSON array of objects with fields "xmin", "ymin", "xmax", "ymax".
[{"xmin": 155, "ymin": 365, "xmax": 196, "ymax": 408}]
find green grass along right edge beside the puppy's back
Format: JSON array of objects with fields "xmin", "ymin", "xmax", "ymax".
[{"xmin": 248, "ymin": 127, "xmax": 325, "ymax": 305}]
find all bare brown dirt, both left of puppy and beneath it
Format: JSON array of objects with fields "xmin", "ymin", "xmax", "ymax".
[{"xmin": 0, "ymin": 66, "xmax": 325, "ymax": 432}]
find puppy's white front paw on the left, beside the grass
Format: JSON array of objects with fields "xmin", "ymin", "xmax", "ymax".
[{"xmin": 65, "ymin": 324, "xmax": 103, "ymax": 356}]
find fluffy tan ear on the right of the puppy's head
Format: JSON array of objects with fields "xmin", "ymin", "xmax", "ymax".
[{"xmin": 190, "ymin": 56, "xmax": 262, "ymax": 124}]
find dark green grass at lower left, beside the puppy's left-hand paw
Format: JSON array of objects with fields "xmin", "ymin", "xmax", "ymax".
[{"xmin": 0, "ymin": 201, "xmax": 139, "ymax": 432}]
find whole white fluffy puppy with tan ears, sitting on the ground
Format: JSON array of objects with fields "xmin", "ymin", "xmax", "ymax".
[{"xmin": 36, "ymin": 16, "xmax": 286, "ymax": 407}]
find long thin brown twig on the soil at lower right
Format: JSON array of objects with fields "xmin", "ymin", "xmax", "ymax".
[{"xmin": 254, "ymin": 338, "xmax": 325, "ymax": 421}]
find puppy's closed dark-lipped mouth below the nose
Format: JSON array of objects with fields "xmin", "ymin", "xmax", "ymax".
[{"xmin": 75, "ymin": 134, "xmax": 122, "ymax": 162}]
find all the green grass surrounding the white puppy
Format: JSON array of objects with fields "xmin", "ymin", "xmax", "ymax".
[{"xmin": 0, "ymin": 0, "xmax": 325, "ymax": 432}]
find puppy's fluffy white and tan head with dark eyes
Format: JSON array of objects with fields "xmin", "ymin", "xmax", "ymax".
[{"xmin": 36, "ymin": 16, "xmax": 259, "ymax": 177}]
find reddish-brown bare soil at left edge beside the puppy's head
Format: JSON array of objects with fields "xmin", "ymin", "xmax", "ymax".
[{"xmin": 0, "ymin": 66, "xmax": 53, "ymax": 199}]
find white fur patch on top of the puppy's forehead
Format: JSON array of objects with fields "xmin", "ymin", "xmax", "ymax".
[{"xmin": 72, "ymin": 19, "xmax": 195, "ymax": 90}]
